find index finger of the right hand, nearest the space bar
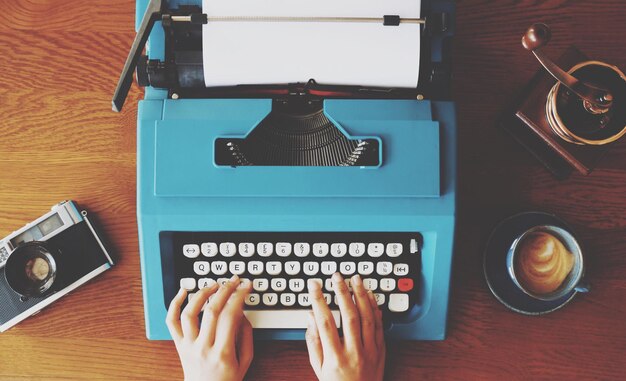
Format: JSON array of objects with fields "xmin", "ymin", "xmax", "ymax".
[{"xmin": 308, "ymin": 279, "xmax": 341, "ymax": 356}]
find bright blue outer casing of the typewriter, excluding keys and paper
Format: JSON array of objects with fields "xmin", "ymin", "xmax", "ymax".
[{"xmin": 137, "ymin": 0, "xmax": 456, "ymax": 340}]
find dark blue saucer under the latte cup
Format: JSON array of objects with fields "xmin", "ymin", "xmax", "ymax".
[{"xmin": 483, "ymin": 212, "xmax": 576, "ymax": 315}]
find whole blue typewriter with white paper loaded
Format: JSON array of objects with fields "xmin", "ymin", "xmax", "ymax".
[{"xmin": 113, "ymin": 0, "xmax": 456, "ymax": 340}]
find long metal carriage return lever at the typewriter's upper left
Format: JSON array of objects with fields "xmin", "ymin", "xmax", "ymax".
[{"xmin": 112, "ymin": 0, "xmax": 163, "ymax": 112}]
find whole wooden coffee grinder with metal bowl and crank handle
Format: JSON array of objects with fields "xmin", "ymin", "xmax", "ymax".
[{"xmin": 500, "ymin": 24, "xmax": 626, "ymax": 177}]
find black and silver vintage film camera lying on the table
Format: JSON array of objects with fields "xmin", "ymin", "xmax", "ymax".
[{"xmin": 0, "ymin": 201, "xmax": 113, "ymax": 332}]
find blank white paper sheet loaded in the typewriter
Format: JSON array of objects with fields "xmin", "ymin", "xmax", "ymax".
[{"xmin": 202, "ymin": 0, "xmax": 421, "ymax": 87}]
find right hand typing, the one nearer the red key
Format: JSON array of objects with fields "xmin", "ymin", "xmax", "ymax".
[{"xmin": 306, "ymin": 273, "xmax": 385, "ymax": 381}]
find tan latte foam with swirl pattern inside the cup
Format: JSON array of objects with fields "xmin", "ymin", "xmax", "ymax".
[{"xmin": 514, "ymin": 232, "xmax": 574, "ymax": 294}]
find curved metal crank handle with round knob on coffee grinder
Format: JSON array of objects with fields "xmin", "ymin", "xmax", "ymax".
[{"xmin": 522, "ymin": 24, "xmax": 613, "ymax": 110}]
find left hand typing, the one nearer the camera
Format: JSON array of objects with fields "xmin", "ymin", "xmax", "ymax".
[{"xmin": 166, "ymin": 275, "xmax": 253, "ymax": 381}]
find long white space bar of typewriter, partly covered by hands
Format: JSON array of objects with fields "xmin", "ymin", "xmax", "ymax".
[{"xmin": 243, "ymin": 310, "xmax": 341, "ymax": 329}]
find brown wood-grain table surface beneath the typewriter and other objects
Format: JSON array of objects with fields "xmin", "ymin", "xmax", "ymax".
[{"xmin": 0, "ymin": 0, "xmax": 626, "ymax": 380}]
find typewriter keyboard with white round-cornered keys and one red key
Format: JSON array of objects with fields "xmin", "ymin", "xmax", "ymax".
[{"xmin": 164, "ymin": 232, "xmax": 422, "ymax": 328}]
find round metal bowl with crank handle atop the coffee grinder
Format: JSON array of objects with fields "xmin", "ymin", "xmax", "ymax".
[{"xmin": 522, "ymin": 24, "xmax": 626, "ymax": 145}]
